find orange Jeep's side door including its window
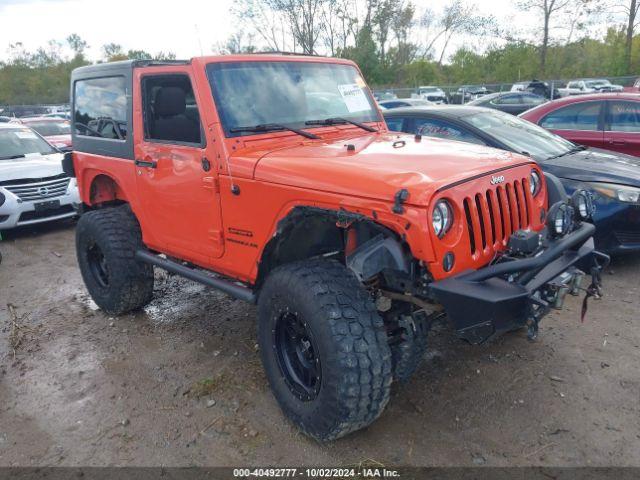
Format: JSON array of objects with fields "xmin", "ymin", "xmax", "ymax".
[{"xmin": 134, "ymin": 67, "xmax": 224, "ymax": 265}]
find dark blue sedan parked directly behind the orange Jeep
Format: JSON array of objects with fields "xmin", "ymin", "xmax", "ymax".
[{"xmin": 383, "ymin": 106, "xmax": 640, "ymax": 253}]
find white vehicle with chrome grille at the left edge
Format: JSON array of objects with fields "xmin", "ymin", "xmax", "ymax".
[{"xmin": 0, "ymin": 123, "xmax": 80, "ymax": 230}]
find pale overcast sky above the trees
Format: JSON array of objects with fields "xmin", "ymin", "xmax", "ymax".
[{"xmin": 0, "ymin": 0, "xmax": 604, "ymax": 60}]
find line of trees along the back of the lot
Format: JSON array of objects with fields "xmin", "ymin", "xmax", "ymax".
[{"xmin": 0, "ymin": 0, "xmax": 640, "ymax": 104}]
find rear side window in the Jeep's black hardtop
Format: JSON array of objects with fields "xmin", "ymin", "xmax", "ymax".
[{"xmin": 73, "ymin": 77, "xmax": 129, "ymax": 141}]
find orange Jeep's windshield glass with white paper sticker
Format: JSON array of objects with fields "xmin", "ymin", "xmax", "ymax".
[{"xmin": 207, "ymin": 61, "xmax": 379, "ymax": 137}]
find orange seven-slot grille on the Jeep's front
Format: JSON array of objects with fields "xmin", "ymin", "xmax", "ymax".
[{"xmin": 463, "ymin": 178, "xmax": 533, "ymax": 256}]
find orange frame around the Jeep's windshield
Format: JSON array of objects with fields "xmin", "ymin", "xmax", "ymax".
[{"xmin": 205, "ymin": 57, "xmax": 382, "ymax": 138}]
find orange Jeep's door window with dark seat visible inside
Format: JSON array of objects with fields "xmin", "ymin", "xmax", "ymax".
[{"xmin": 142, "ymin": 74, "xmax": 203, "ymax": 145}]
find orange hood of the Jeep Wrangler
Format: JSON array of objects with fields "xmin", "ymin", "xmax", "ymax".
[{"xmin": 254, "ymin": 134, "xmax": 531, "ymax": 205}]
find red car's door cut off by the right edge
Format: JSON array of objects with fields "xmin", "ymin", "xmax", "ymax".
[{"xmin": 604, "ymin": 100, "xmax": 640, "ymax": 157}]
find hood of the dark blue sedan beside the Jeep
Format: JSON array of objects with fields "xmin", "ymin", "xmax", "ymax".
[{"xmin": 541, "ymin": 148, "xmax": 640, "ymax": 187}]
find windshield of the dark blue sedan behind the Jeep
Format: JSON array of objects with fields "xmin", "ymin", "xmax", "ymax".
[{"xmin": 466, "ymin": 111, "xmax": 576, "ymax": 160}]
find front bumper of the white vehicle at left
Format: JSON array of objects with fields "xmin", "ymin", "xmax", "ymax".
[{"xmin": 0, "ymin": 179, "xmax": 80, "ymax": 230}]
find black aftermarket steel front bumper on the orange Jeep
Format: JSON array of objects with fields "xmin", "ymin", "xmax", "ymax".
[{"xmin": 431, "ymin": 223, "xmax": 608, "ymax": 344}]
